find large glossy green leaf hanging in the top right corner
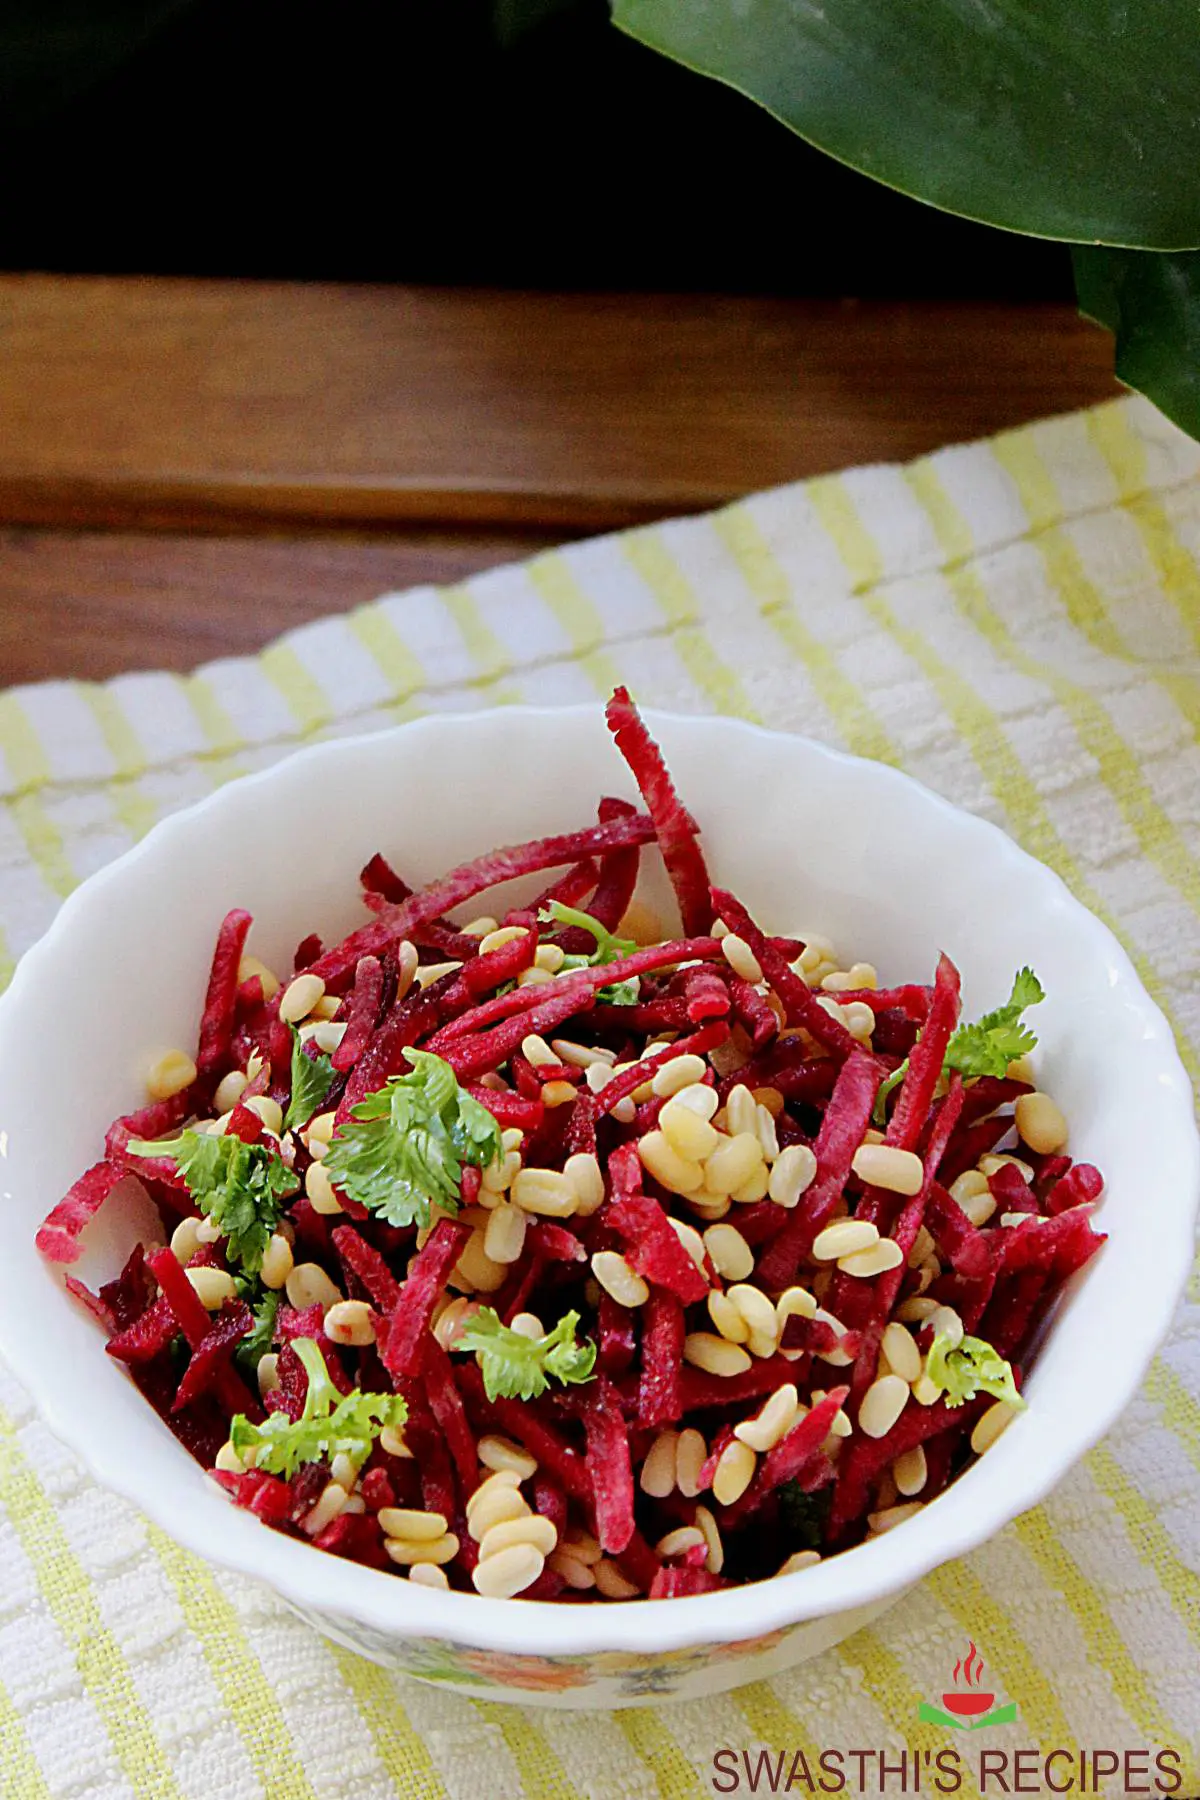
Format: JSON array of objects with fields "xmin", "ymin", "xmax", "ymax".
[{"xmin": 613, "ymin": 0, "xmax": 1200, "ymax": 250}]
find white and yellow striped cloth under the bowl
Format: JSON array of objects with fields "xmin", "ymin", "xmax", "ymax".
[{"xmin": 0, "ymin": 400, "xmax": 1200, "ymax": 1800}]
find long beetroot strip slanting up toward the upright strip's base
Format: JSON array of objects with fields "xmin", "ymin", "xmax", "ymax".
[{"xmin": 311, "ymin": 814, "xmax": 655, "ymax": 983}]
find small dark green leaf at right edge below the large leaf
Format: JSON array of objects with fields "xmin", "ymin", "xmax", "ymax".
[{"xmin": 1072, "ymin": 245, "xmax": 1200, "ymax": 437}]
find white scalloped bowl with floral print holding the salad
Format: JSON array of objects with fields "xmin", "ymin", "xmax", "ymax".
[{"xmin": 0, "ymin": 707, "xmax": 1200, "ymax": 1706}]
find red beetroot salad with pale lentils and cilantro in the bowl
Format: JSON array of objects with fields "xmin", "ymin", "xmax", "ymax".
[{"xmin": 38, "ymin": 689, "xmax": 1103, "ymax": 1602}]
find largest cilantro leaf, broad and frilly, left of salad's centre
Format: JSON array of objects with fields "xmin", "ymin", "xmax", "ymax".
[{"xmin": 326, "ymin": 1049, "xmax": 504, "ymax": 1226}]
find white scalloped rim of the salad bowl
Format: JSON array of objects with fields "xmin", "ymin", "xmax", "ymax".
[{"xmin": 0, "ymin": 706, "xmax": 1200, "ymax": 1656}]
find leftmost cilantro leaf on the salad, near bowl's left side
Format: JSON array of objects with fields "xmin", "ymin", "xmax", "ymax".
[{"xmin": 130, "ymin": 1130, "xmax": 300, "ymax": 1274}]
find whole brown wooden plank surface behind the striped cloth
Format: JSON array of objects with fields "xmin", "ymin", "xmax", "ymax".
[{"xmin": 0, "ymin": 275, "xmax": 1117, "ymax": 684}]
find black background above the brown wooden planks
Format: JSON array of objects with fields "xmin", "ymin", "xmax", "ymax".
[{"xmin": 0, "ymin": 0, "xmax": 1072, "ymax": 301}]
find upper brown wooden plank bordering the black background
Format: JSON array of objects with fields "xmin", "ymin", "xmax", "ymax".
[{"xmin": 0, "ymin": 275, "xmax": 1115, "ymax": 529}]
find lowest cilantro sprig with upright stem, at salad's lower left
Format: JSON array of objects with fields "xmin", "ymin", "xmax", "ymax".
[{"xmin": 228, "ymin": 1337, "xmax": 408, "ymax": 1480}]
